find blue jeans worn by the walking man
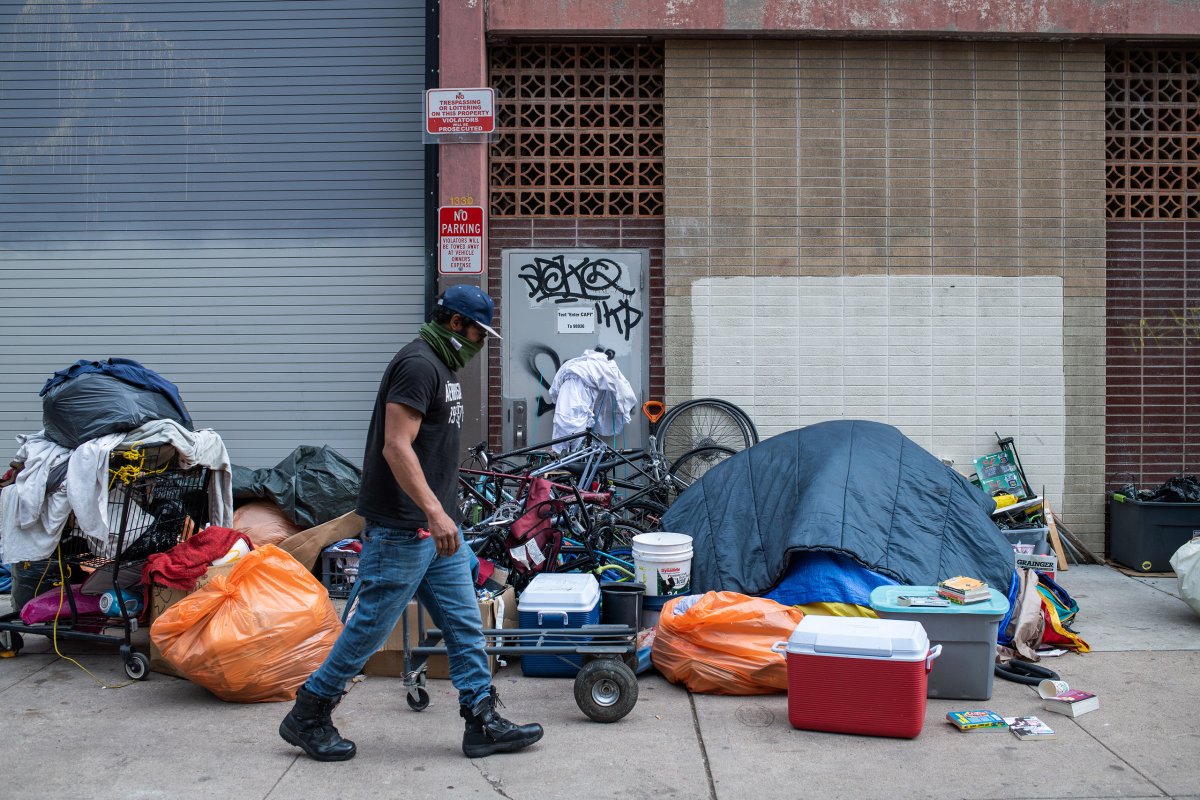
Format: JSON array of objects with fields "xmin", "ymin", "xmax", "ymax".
[{"xmin": 305, "ymin": 522, "xmax": 492, "ymax": 708}]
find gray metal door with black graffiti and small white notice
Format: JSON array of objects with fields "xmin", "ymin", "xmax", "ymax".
[{"xmin": 503, "ymin": 249, "xmax": 649, "ymax": 449}]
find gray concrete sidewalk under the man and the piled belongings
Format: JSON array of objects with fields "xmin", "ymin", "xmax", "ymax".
[{"xmin": 0, "ymin": 566, "xmax": 1200, "ymax": 800}]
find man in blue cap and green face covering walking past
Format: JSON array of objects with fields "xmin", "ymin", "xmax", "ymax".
[{"xmin": 280, "ymin": 285, "xmax": 542, "ymax": 762}]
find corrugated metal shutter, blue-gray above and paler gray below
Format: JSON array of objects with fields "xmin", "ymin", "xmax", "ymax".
[{"xmin": 0, "ymin": 0, "xmax": 426, "ymax": 471}]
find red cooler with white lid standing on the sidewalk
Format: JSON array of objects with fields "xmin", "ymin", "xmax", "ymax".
[{"xmin": 772, "ymin": 614, "xmax": 942, "ymax": 739}]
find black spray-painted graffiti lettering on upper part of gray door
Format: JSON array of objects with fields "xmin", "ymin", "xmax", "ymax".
[{"xmin": 517, "ymin": 255, "xmax": 646, "ymax": 342}]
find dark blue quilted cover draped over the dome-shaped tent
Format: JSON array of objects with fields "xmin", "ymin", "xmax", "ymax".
[{"xmin": 662, "ymin": 420, "xmax": 1014, "ymax": 602}]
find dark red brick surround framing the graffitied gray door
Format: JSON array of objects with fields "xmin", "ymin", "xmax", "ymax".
[{"xmin": 487, "ymin": 217, "xmax": 664, "ymax": 447}]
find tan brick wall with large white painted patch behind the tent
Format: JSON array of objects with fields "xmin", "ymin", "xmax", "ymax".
[{"xmin": 665, "ymin": 41, "xmax": 1105, "ymax": 547}]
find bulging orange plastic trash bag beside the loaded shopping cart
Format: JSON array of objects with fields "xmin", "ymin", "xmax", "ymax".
[{"xmin": 150, "ymin": 545, "xmax": 342, "ymax": 703}]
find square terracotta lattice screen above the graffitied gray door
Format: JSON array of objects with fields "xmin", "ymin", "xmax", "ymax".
[{"xmin": 491, "ymin": 44, "xmax": 662, "ymax": 218}]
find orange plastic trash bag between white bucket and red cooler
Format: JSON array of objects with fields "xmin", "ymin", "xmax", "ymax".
[{"xmin": 650, "ymin": 591, "xmax": 804, "ymax": 694}]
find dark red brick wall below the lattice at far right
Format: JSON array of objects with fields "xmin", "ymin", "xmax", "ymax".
[{"xmin": 1105, "ymin": 219, "xmax": 1200, "ymax": 488}]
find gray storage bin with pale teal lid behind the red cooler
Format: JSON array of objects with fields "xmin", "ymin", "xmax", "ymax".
[{"xmin": 871, "ymin": 587, "xmax": 1008, "ymax": 700}]
